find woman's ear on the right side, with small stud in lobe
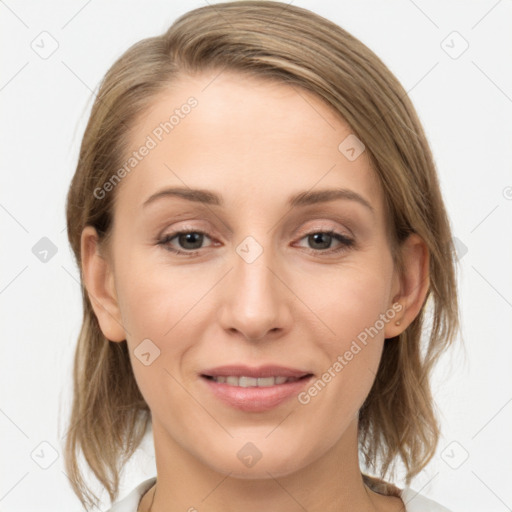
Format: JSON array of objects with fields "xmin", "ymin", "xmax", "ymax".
[{"xmin": 384, "ymin": 233, "xmax": 430, "ymax": 338}]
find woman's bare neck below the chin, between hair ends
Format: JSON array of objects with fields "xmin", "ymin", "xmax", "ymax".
[{"xmin": 139, "ymin": 420, "xmax": 404, "ymax": 512}]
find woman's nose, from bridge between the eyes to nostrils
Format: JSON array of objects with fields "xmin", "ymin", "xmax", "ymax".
[{"xmin": 219, "ymin": 241, "xmax": 293, "ymax": 341}]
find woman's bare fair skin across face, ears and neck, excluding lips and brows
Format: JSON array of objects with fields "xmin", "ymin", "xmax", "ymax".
[{"xmin": 82, "ymin": 71, "xmax": 428, "ymax": 512}]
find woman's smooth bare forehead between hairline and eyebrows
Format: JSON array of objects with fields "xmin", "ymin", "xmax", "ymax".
[{"xmin": 112, "ymin": 71, "xmax": 382, "ymax": 216}]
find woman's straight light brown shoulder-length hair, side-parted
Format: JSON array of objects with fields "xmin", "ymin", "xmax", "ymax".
[{"xmin": 64, "ymin": 1, "xmax": 459, "ymax": 508}]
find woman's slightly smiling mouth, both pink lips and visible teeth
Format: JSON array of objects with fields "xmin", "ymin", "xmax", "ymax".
[{"xmin": 200, "ymin": 366, "xmax": 314, "ymax": 412}]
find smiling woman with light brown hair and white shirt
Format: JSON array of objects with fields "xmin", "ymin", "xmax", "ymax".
[{"xmin": 66, "ymin": 1, "xmax": 458, "ymax": 512}]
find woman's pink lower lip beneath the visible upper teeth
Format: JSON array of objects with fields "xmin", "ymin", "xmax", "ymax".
[{"xmin": 201, "ymin": 375, "xmax": 313, "ymax": 412}]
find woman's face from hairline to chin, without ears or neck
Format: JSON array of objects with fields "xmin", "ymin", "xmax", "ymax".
[{"xmin": 88, "ymin": 72, "xmax": 408, "ymax": 478}]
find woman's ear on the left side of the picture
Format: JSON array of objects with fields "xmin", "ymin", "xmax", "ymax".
[{"xmin": 81, "ymin": 226, "xmax": 126, "ymax": 341}]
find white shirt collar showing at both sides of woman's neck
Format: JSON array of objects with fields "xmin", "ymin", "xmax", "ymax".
[{"xmin": 107, "ymin": 477, "xmax": 451, "ymax": 512}]
